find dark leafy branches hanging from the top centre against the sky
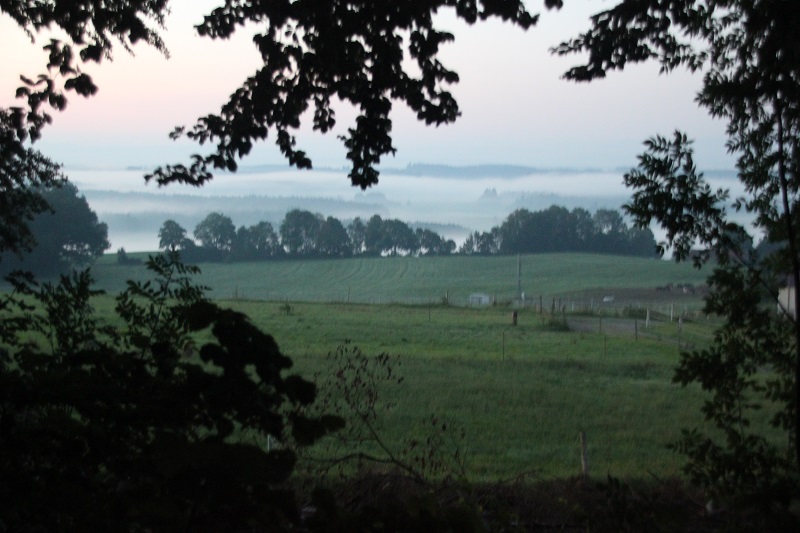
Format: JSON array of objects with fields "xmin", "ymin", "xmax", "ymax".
[{"xmin": 147, "ymin": 0, "xmax": 561, "ymax": 188}]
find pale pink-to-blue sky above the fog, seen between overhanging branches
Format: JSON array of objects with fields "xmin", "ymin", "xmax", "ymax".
[{"xmin": 0, "ymin": 0, "xmax": 733, "ymax": 177}]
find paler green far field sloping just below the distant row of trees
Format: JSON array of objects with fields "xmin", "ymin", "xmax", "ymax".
[{"xmin": 94, "ymin": 254, "xmax": 707, "ymax": 307}]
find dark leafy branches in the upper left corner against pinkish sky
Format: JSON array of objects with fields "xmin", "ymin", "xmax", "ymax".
[{"xmin": 0, "ymin": 0, "xmax": 168, "ymax": 262}]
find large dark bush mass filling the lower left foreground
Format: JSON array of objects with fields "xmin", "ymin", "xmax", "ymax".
[{"xmin": 0, "ymin": 254, "xmax": 341, "ymax": 531}]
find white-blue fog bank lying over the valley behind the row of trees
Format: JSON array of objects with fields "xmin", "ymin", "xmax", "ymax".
[{"xmin": 67, "ymin": 166, "xmax": 741, "ymax": 251}]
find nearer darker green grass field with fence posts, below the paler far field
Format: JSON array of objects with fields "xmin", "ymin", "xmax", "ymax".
[{"xmin": 217, "ymin": 302, "xmax": 711, "ymax": 480}]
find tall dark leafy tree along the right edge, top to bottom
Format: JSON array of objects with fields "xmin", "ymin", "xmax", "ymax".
[{"xmin": 554, "ymin": 0, "xmax": 800, "ymax": 503}]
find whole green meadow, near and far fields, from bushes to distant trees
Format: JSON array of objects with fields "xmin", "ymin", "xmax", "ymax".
[{"xmin": 75, "ymin": 254, "xmax": 752, "ymax": 481}]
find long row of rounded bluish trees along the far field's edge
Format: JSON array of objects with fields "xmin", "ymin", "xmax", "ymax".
[{"xmin": 158, "ymin": 206, "xmax": 656, "ymax": 262}]
